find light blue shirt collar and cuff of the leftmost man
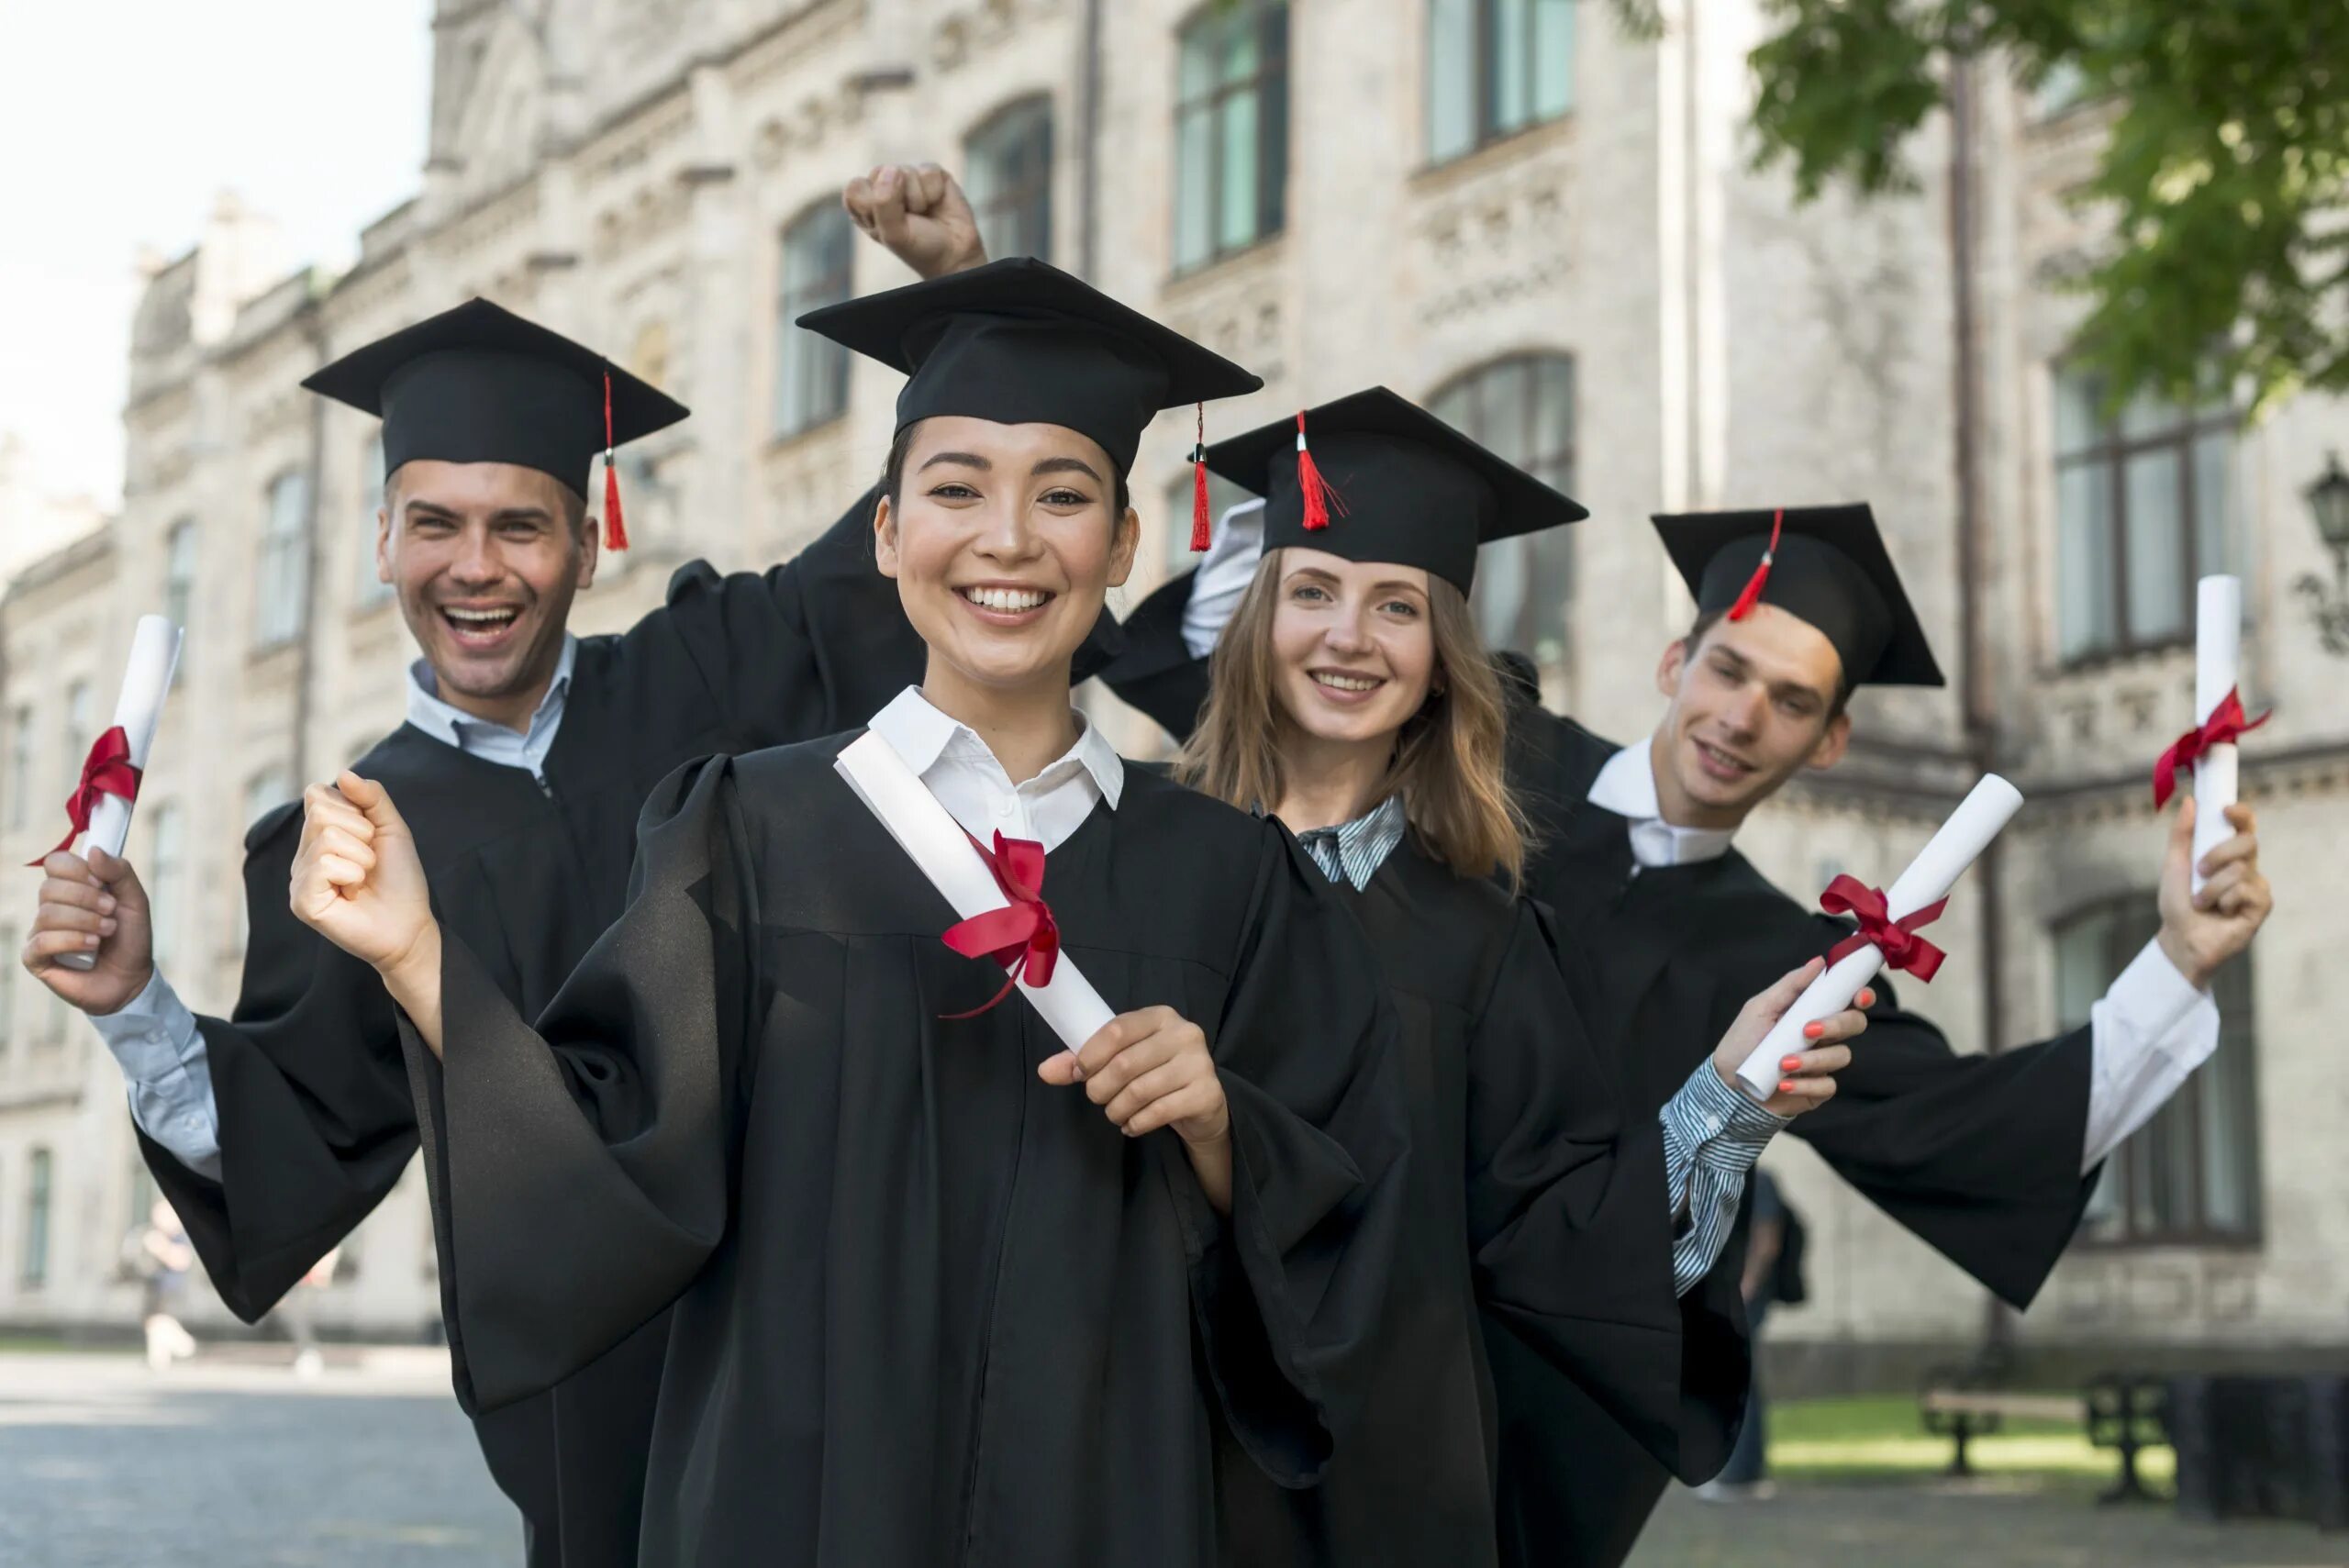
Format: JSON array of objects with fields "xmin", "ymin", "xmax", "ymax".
[{"xmin": 89, "ymin": 634, "xmax": 580, "ymax": 1181}]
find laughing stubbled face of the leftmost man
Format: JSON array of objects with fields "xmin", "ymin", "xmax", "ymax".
[{"xmin": 376, "ymin": 458, "xmax": 596, "ymax": 723}]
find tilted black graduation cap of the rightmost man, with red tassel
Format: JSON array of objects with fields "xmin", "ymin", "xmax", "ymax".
[{"xmin": 1653, "ymin": 502, "xmax": 1943, "ymax": 685}]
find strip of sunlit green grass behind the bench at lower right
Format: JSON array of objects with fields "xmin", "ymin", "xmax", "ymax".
[{"xmin": 1769, "ymin": 1395, "xmax": 2177, "ymax": 1491}]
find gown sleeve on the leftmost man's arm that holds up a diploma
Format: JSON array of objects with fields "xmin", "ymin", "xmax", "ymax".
[{"xmin": 139, "ymin": 806, "xmax": 416, "ymax": 1321}]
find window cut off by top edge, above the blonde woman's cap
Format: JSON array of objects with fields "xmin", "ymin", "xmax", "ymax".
[{"xmin": 1428, "ymin": 0, "xmax": 1581, "ymax": 164}]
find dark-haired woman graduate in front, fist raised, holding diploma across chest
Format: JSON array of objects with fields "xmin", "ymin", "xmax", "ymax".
[{"xmin": 291, "ymin": 261, "xmax": 1405, "ymax": 1568}]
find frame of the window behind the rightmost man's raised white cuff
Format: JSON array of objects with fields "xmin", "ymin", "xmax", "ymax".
[{"xmin": 2048, "ymin": 890, "xmax": 2266, "ymax": 1253}]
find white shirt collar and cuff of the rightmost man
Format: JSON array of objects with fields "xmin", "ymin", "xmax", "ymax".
[{"xmin": 1590, "ymin": 737, "xmax": 2218, "ymax": 1173}]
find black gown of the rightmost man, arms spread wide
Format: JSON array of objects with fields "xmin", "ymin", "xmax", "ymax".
[{"xmin": 1102, "ymin": 573, "xmax": 2093, "ymax": 1568}]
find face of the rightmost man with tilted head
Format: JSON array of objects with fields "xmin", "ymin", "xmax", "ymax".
[{"xmin": 1653, "ymin": 604, "xmax": 1851, "ymax": 828}]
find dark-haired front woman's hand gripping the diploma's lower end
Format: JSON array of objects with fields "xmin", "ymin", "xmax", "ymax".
[{"xmin": 1036, "ymin": 1007, "xmax": 1230, "ymax": 1214}]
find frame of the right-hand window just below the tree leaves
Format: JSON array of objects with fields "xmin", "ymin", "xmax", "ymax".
[{"xmin": 2048, "ymin": 361, "xmax": 2243, "ymax": 669}]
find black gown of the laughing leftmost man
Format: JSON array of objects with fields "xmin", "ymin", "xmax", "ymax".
[{"xmin": 141, "ymin": 497, "xmax": 923, "ymax": 1568}]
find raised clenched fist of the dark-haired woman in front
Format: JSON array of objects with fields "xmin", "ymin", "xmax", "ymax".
[{"xmin": 289, "ymin": 773, "xmax": 440, "ymax": 1002}]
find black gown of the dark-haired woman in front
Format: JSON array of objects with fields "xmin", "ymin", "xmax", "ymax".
[{"xmin": 408, "ymin": 737, "xmax": 1405, "ymax": 1568}]
